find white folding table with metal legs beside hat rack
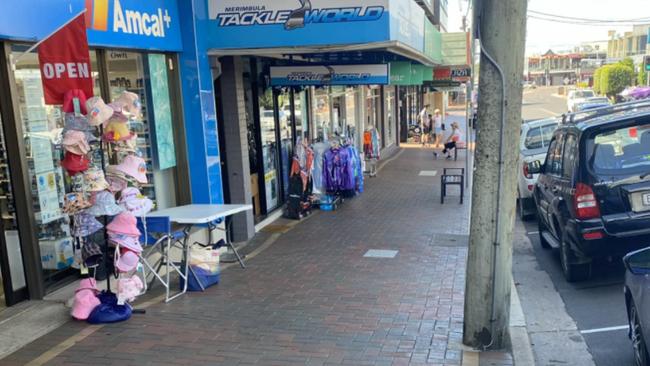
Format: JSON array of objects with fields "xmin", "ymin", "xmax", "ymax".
[{"xmin": 147, "ymin": 204, "xmax": 253, "ymax": 293}]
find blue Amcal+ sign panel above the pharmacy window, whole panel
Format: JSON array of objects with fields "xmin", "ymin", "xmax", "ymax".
[{"xmin": 86, "ymin": 0, "xmax": 182, "ymax": 50}]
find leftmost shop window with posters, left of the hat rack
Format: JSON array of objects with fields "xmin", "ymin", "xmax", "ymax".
[{"xmin": 11, "ymin": 45, "xmax": 101, "ymax": 285}]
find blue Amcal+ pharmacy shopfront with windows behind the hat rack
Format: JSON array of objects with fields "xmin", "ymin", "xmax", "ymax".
[{"xmin": 0, "ymin": 0, "xmax": 222, "ymax": 308}]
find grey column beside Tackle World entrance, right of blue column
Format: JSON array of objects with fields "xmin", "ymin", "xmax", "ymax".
[{"xmin": 218, "ymin": 56, "xmax": 255, "ymax": 242}]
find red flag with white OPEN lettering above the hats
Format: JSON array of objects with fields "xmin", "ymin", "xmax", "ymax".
[{"xmin": 38, "ymin": 13, "xmax": 93, "ymax": 104}]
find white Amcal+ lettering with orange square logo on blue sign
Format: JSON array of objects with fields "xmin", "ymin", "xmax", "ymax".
[{"xmin": 86, "ymin": 0, "xmax": 172, "ymax": 37}]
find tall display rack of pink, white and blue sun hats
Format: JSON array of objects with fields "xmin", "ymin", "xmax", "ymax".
[{"xmin": 61, "ymin": 90, "xmax": 154, "ymax": 324}]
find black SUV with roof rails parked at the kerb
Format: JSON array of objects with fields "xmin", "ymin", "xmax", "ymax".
[{"xmin": 529, "ymin": 101, "xmax": 650, "ymax": 281}]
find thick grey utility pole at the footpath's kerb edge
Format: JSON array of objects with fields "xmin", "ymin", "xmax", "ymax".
[{"xmin": 463, "ymin": 0, "xmax": 528, "ymax": 349}]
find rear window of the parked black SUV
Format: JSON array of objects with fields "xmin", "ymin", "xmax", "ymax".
[{"xmin": 586, "ymin": 122, "xmax": 650, "ymax": 179}]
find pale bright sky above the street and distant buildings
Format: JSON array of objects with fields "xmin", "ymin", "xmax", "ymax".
[{"xmin": 447, "ymin": 0, "xmax": 650, "ymax": 55}]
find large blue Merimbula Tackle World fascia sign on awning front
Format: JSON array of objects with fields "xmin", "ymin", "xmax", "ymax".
[{"xmin": 207, "ymin": 0, "xmax": 390, "ymax": 49}]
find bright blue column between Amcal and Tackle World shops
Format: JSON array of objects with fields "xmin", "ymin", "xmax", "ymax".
[{"xmin": 178, "ymin": 0, "xmax": 223, "ymax": 204}]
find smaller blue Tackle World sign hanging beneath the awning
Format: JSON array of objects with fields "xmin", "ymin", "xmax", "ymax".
[{"xmin": 271, "ymin": 64, "xmax": 390, "ymax": 86}]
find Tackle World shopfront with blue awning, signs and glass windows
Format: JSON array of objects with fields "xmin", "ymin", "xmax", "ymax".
[{"xmin": 195, "ymin": 0, "xmax": 436, "ymax": 238}]
